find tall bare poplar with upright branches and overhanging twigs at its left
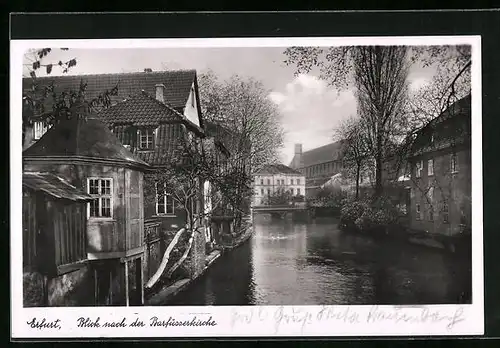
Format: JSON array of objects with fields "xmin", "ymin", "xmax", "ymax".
[{"xmin": 284, "ymin": 46, "xmax": 409, "ymax": 195}]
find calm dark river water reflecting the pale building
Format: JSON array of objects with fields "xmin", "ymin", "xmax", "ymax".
[{"xmin": 168, "ymin": 216, "xmax": 471, "ymax": 305}]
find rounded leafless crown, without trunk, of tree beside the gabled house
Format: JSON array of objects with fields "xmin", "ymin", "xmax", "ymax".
[{"xmin": 199, "ymin": 71, "xmax": 284, "ymax": 172}]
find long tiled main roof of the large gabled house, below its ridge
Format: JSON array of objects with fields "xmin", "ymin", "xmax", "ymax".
[{"xmin": 23, "ymin": 70, "xmax": 196, "ymax": 109}]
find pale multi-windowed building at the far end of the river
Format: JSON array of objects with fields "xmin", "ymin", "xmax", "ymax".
[{"xmin": 253, "ymin": 164, "xmax": 306, "ymax": 206}]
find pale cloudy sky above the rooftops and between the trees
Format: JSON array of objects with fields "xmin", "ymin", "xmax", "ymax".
[{"xmin": 27, "ymin": 47, "xmax": 431, "ymax": 165}]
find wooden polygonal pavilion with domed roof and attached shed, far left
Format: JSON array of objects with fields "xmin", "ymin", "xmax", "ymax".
[{"xmin": 23, "ymin": 114, "xmax": 149, "ymax": 306}]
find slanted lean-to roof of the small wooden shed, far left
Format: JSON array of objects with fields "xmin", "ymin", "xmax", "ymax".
[{"xmin": 23, "ymin": 172, "xmax": 92, "ymax": 201}]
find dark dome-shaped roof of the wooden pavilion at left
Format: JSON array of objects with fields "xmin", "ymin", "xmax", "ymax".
[{"xmin": 23, "ymin": 118, "xmax": 147, "ymax": 166}]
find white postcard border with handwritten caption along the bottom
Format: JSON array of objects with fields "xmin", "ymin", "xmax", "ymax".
[{"xmin": 10, "ymin": 36, "xmax": 484, "ymax": 338}]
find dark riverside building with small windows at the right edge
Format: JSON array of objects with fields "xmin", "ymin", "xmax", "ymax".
[{"xmin": 408, "ymin": 95, "xmax": 472, "ymax": 235}]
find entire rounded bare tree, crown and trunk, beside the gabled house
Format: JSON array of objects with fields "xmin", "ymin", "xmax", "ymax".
[{"xmin": 199, "ymin": 71, "xmax": 284, "ymax": 225}]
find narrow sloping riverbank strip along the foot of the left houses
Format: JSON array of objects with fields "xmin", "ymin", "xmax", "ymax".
[{"xmin": 144, "ymin": 225, "xmax": 253, "ymax": 306}]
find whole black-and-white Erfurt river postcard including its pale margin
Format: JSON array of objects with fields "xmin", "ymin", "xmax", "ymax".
[{"xmin": 11, "ymin": 36, "xmax": 482, "ymax": 334}]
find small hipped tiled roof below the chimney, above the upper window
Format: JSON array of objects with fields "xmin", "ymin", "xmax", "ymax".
[{"xmin": 96, "ymin": 91, "xmax": 184, "ymax": 126}]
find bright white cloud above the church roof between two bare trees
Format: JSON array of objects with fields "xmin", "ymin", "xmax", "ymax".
[{"xmin": 269, "ymin": 74, "xmax": 356, "ymax": 164}]
